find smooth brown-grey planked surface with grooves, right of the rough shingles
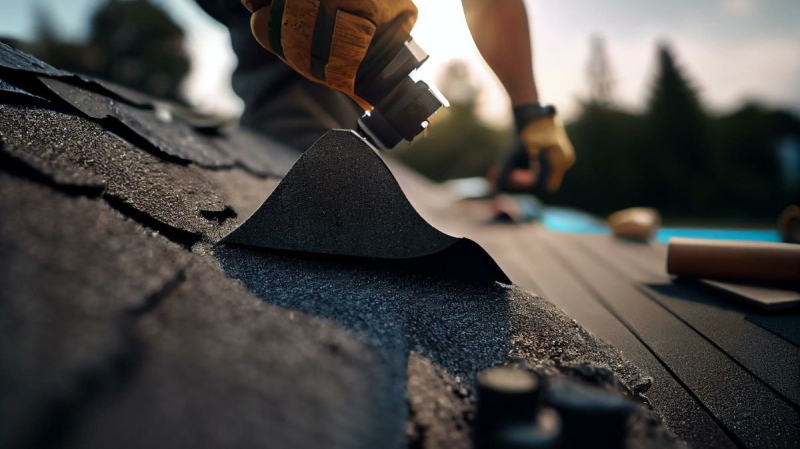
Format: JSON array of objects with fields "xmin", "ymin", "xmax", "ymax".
[{"xmin": 396, "ymin": 166, "xmax": 800, "ymax": 448}]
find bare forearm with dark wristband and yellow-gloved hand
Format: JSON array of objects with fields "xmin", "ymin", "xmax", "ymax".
[{"xmin": 462, "ymin": 0, "xmax": 575, "ymax": 192}]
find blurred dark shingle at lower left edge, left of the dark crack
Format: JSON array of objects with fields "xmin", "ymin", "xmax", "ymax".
[{"xmin": 0, "ymin": 174, "xmax": 188, "ymax": 447}]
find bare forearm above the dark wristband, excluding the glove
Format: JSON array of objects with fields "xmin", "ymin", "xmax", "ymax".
[{"xmin": 462, "ymin": 0, "xmax": 539, "ymax": 106}]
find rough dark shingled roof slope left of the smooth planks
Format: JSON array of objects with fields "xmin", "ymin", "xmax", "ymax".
[{"xmin": 0, "ymin": 46, "xmax": 678, "ymax": 447}]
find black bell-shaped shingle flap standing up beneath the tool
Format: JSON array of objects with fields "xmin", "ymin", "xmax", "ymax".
[{"xmin": 220, "ymin": 131, "xmax": 507, "ymax": 282}]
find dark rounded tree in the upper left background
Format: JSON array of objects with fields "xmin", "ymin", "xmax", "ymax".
[{"xmin": 25, "ymin": 0, "xmax": 190, "ymax": 101}]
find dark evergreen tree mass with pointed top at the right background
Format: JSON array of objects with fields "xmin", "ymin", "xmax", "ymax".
[{"xmin": 548, "ymin": 46, "xmax": 800, "ymax": 219}]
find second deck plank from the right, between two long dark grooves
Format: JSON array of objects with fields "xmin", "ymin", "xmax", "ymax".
[{"xmin": 536, "ymin": 233, "xmax": 800, "ymax": 447}]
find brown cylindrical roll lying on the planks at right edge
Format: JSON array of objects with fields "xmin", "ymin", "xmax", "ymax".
[{"xmin": 667, "ymin": 238, "xmax": 800, "ymax": 283}]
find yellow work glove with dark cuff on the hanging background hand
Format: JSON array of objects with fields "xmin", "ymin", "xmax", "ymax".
[{"xmin": 514, "ymin": 104, "xmax": 575, "ymax": 192}]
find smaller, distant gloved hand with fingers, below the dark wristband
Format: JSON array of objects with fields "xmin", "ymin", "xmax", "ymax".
[{"xmin": 498, "ymin": 103, "xmax": 575, "ymax": 192}]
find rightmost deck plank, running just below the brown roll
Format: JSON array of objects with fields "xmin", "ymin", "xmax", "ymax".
[{"xmin": 581, "ymin": 236, "xmax": 800, "ymax": 405}]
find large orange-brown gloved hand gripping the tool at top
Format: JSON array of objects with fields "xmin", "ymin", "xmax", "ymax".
[{"xmin": 242, "ymin": 0, "xmax": 417, "ymax": 110}]
